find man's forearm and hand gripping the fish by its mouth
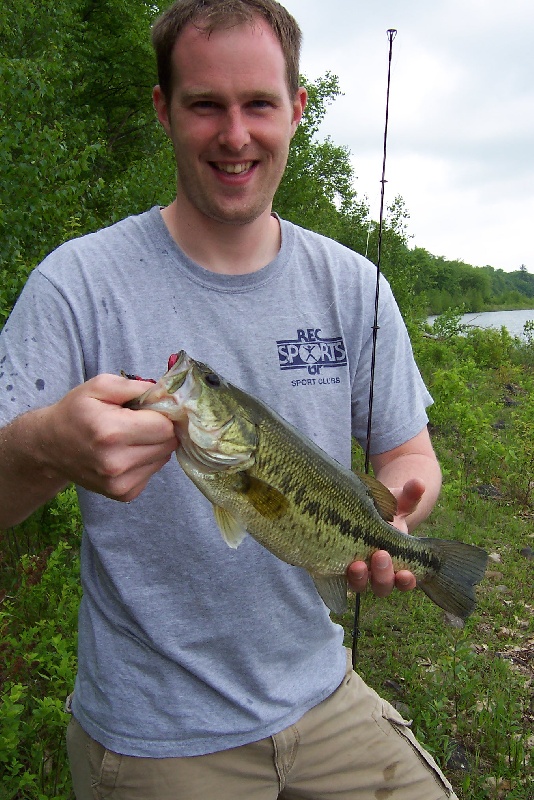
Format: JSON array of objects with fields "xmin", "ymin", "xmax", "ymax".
[{"xmin": 0, "ymin": 375, "xmax": 177, "ymax": 529}]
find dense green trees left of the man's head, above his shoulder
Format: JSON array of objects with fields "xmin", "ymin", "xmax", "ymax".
[{"xmin": 0, "ymin": 0, "xmax": 174, "ymax": 322}]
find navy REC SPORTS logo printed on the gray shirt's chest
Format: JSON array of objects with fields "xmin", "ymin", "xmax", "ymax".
[{"xmin": 276, "ymin": 328, "xmax": 347, "ymax": 380}]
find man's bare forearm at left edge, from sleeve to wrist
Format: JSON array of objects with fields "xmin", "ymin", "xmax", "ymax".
[{"xmin": 0, "ymin": 409, "xmax": 69, "ymax": 530}]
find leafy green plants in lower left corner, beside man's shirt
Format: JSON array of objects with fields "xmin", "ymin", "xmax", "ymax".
[{"xmin": 0, "ymin": 490, "xmax": 81, "ymax": 800}]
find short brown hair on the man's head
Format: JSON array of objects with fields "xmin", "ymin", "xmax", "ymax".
[{"xmin": 152, "ymin": 0, "xmax": 302, "ymax": 102}]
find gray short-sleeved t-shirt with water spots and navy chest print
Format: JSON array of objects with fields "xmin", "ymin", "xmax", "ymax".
[{"xmin": 0, "ymin": 207, "xmax": 431, "ymax": 757}]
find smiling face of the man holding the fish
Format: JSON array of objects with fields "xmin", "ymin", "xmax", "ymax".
[{"xmin": 154, "ymin": 20, "xmax": 306, "ymax": 225}]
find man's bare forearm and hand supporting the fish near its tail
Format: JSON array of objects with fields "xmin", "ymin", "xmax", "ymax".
[{"xmin": 347, "ymin": 427, "xmax": 441, "ymax": 597}]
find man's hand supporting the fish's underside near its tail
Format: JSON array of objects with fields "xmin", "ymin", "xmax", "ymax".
[{"xmin": 347, "ymin": 478, "xmax": 425, "ymax": 597}]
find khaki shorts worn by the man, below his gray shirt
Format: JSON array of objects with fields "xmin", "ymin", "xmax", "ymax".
[{"xmin": 67, "ymin": 656, "xmax": 456, "ymax": 800}]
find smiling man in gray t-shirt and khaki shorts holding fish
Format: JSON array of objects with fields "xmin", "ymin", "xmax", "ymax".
[{"xmin": 0, "ymin": 0, "xmax": 453, "ymax": 800}]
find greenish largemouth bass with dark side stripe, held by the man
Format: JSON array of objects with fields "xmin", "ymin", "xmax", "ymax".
[{"xmin": 123, "ymin": 350, "xmax": 488, "ymax": 619}]
